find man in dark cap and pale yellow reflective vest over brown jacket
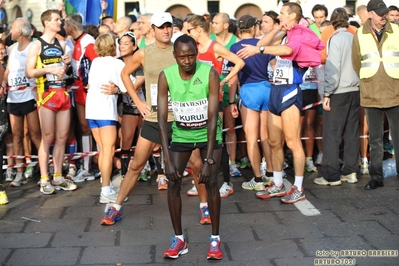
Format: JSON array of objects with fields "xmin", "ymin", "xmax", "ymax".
[{"xmin": 352, "ymin": 0, "xmax": 399, "ymax": 190}]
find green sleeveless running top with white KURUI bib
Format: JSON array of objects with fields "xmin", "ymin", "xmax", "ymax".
[{"xmin": 164, "ymin": 62, "xmax": 222, "ymax": 144}]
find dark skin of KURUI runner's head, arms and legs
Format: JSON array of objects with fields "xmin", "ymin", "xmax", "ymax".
[{"xmin": 158, "ymin": 42, "xmax": 222, "ymax": 235}]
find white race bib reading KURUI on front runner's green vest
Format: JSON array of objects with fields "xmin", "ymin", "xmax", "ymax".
[{"xmin": 172, "ymin": 98, "xmax": 208, "ymax": 129}]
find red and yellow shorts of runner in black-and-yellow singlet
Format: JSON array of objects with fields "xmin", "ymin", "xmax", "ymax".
[{"xmin": 40, "ymin": 89, "xmax": 71, "ymax": 112}]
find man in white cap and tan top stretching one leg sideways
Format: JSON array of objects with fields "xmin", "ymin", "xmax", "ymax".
[{"xmin": 101, "ymin": 12, "xmax": 175, "ymax": 225}]
